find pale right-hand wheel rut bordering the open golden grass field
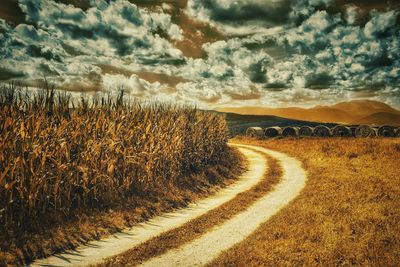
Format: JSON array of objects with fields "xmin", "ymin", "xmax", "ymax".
[{"xmin": 141, "ymin": 145, "xmax": 306, "ymax": 267}]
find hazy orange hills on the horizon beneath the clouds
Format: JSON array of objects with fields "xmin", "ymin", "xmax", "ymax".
[{"xmin": 219, "ymin": 100, "xmax": 400, "ymax": 124}]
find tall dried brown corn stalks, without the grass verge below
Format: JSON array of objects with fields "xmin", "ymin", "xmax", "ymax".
[{"xmin": 0, "ymin": 85, "xmax": 228, "ymax": 237}]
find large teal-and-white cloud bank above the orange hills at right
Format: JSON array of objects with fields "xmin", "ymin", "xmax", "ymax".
[{"xmin": 186, "ymin": 3, "xmax": 400, "ymax": 105}]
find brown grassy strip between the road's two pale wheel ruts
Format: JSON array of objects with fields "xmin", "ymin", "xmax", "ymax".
[{"xmin": 99, "ymin": 149, "xmax": 282, "ymax": 266}]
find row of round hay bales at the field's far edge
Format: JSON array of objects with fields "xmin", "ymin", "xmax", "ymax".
[{"xmin": 246, "ymin": 125, "xmax": 400, "ymax": 138}]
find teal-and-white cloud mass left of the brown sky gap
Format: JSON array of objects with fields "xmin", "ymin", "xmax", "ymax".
[{"xmin": 0, "ymin": 0, "xmax": 185, "ymax": 93}]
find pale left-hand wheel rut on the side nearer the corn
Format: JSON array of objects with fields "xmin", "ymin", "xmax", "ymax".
[{"xmin": 29, "ymin": 145, "xmax": 267, "ymax": 266}]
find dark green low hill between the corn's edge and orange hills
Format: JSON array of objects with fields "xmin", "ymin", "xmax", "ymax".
[{"xmin": 221, "ymin": 112, "xmax": 335, "ymax": 136}]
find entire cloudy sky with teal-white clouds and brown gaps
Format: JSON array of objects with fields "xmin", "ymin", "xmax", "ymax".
[{"xmin": 0, "ymin": 0, "xmax": 400, "ymax": 108}]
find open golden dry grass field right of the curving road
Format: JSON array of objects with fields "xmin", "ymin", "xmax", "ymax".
[{"xmin": 211, "ymin": 138, "xmax": 400, "ymax": 266}]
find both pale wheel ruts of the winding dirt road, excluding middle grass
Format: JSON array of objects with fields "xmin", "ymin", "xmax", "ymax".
[{"xmin": 31, "ymin": 144, "xmax": 306, "ymax": 266}]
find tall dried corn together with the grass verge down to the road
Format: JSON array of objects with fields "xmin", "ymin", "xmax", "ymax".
[{"xmin": 0, "ymin": 83, "xmax": 240, "ymax": 265}]
